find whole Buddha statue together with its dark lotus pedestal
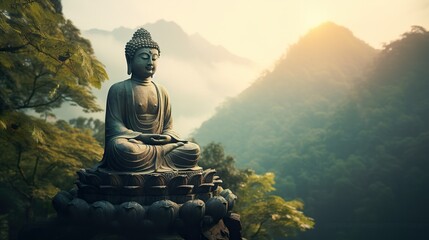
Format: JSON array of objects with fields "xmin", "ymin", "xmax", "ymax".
[{"xmin": 50, "ymin": 28, "xmax": 241, "ymax": 239}]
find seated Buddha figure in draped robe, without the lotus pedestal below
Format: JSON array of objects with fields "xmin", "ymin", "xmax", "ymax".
[{"xmin": 97, "ymin": 28, "xmax": 201, "ymax": 173}]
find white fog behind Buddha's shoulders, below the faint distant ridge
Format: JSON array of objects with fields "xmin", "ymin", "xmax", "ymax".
[{"xmin": 55, "ymin": 26, "xmax": 262, "ymax": 137}]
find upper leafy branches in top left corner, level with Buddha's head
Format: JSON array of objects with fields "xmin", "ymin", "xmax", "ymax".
[{"xmin": 0, "ymin": 0, "xmax": 107, "ymax": 112}]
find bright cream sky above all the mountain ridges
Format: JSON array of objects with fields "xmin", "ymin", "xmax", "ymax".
[{"xmin": 62, "ymin": 0, "xmax": 429, "ymax": 66}]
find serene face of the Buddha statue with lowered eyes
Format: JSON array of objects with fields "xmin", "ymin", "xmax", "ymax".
[{"xmin": 131, "ymin": 48, "xmax": 159, "ymax": 79}]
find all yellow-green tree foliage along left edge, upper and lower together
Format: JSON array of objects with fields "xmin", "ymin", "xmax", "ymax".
[{"xmin": 0, "ymin": 0, "xmax": 107, "ymax": 234}]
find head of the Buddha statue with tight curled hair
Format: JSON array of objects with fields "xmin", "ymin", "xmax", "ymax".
[{"xmin": 125, "ymin": 28, "xmax": 161, "ymax": 75}]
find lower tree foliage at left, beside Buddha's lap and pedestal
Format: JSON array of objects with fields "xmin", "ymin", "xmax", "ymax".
[{"xmin": 0, "ymin": 112, "xmax": 103, "ymax": 222}]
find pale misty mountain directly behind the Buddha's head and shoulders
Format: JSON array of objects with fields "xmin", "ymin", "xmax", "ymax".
[{"xmin": 57, "ymin": 20, "xmax": 260, "ymax": 137}]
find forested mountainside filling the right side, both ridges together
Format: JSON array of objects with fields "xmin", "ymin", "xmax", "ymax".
[{"xmin": 195, "ymin": 23, "xmax": 429, "ymax": 240}]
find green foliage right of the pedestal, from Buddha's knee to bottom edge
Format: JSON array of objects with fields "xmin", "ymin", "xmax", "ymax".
[{"xmin": 199, "ymin": 143, "xmax": 314, "ymax": 239}]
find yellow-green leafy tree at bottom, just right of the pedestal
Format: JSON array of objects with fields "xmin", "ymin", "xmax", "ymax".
[{"xmin": 237, "ymin": 173, "xmax": 314, "ymax": 239}]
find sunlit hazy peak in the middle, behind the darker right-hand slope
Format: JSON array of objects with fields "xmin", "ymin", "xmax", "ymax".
[{"xmin": 194, "ymin": 22, "xmax": 377, "ymax": 171}]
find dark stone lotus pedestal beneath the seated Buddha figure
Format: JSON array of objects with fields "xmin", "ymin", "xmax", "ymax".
[{"xmin": 49, "ymin": 169, "xmax": 241, "ymax": 239}]
